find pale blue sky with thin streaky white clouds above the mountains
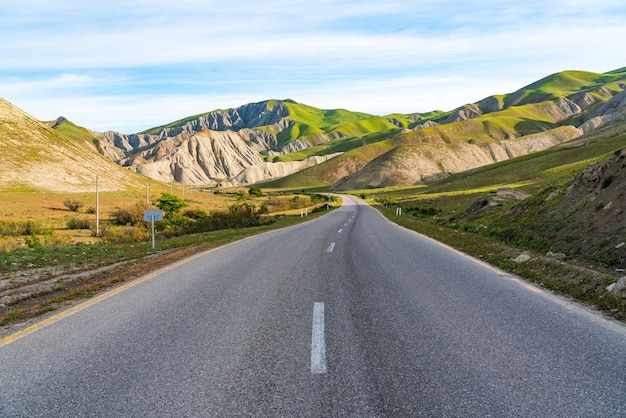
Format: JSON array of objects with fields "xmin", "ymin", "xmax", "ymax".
[{"xmin": 0, "ymin": 0, "xmax": 626, "ymax": 133}]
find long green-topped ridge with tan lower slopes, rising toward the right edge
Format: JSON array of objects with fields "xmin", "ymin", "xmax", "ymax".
[{"xmin": 271, "ymin": 69, "xmax": 626, "ymax": 190}]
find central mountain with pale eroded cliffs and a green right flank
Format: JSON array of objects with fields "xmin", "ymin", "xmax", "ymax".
[{"xmin": 96, "ymin": 100, "xmax": 401, "ymax": 185}]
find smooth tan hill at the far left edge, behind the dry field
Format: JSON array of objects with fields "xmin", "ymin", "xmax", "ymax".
[{"xmin": 0, "ymin": 98, "xmax": 151, "ymax": 192}]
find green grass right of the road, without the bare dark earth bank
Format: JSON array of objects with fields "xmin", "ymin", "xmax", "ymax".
[{"xmin": 351, "ymin": 130, "xmax": 626, "ymax": 320}]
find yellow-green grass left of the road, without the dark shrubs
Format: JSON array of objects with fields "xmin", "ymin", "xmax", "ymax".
[{"xmin": 0, "ymin": 186, "xmax": 338, "ymax": 325}]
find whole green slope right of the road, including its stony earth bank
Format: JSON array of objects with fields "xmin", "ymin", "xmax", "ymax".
[{"xmin": 352, "ymin": 134, "xmax": 626, "ymax": 320}]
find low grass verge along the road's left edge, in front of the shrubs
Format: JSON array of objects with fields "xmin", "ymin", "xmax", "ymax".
[{"xmin": 0, "ymin": 199, "xmax": 337, "ymax": 325}]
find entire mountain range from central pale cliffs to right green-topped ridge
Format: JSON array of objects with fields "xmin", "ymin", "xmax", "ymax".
[{"xmin": 89, "ymin": 69, "xmax": 626, "ymax": 190}]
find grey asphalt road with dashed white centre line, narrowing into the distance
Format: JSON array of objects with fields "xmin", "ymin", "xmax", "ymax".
[{"xmin": 0, "ymin": 197, "xmax": 626, "ymax": 417}]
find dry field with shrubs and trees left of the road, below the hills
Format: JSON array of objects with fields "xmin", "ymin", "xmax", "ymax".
[{"xmin": 0, "ymin": 188, "xmax": 338, "ymax": 325}]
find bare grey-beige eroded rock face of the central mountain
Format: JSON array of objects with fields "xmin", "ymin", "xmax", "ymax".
[{"xmin": 95, "ymin": 101, "xmax": 330, "ymax": 186}]
